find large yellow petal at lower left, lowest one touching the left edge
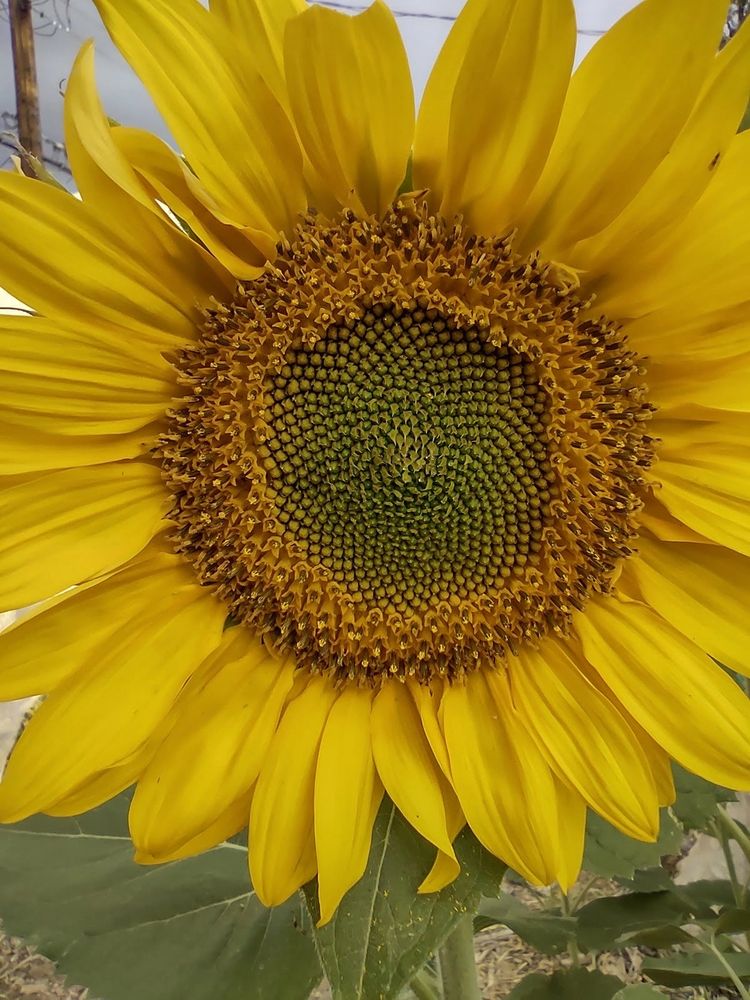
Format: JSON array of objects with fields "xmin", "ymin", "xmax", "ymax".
[{"xmin": 0, "ymin": 569, "xmax": 225, "ymax": 823}]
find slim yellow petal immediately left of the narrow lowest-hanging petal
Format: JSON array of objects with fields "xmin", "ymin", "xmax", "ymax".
[{"xmin": 249, "ymin": 677, "xmax": 336, "ymax": 906}]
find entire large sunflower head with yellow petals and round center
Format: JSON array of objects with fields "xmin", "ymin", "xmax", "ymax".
[{"xmin": 0, "ymin": 0, "xmax": 750, "ymax": 921}]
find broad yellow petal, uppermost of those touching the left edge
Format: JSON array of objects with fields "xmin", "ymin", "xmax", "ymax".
[{"xmin": 0, "ymin": 171, "xmax": 226, "ymax": 350}]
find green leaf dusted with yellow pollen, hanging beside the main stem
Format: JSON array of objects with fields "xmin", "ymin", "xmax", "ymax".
[{"xmin": 306, "ymin": 801, "xmax": 505, "ymax": 1000}]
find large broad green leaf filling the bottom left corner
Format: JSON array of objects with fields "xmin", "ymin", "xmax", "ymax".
[{"xmin": 0, "ymin": 796, "xmax": 322, "ymax": 1000}]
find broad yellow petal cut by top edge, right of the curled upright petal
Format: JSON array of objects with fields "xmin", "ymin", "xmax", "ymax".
[{"xmin": 95, "ymin": 0, "xmax": 306, "ymax": 243}]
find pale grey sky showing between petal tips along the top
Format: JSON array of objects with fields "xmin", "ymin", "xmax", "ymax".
[{"xmin": 0, "ymin": 0, "xmax": 636, "ymax": 184}]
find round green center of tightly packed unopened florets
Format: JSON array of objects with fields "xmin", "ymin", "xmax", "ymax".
[{"xmin": 260, "ymin": 304, "xmax": 556, "ymax": 612}]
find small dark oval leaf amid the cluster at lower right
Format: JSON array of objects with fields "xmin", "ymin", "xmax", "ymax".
[{"xmin": 578, "ymin": 892, "xmax": 690, "ymax": 951}]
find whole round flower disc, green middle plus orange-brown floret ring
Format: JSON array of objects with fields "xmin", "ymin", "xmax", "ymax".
[{"xmin": 156, "ymin": 197, "xmax": 654, "ymax": 683}]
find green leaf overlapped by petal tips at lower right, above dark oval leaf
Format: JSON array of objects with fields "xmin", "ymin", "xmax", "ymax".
[{"xmin": 583, "ymin": 809, "xmax": 683, "ymax": 878}]
